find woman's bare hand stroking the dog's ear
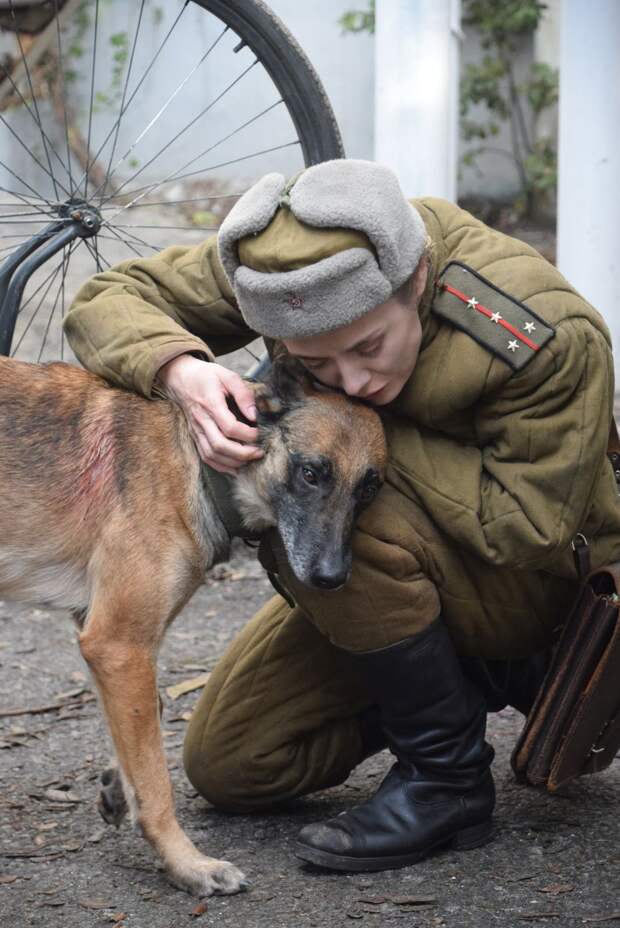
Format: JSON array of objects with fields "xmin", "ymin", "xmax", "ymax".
[{"xmin": 157, "ymin": 354, "xmax": 263, "ymax": 474}]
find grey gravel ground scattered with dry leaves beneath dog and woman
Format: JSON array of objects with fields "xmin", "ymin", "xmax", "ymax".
[{"xmin": 0, "ymin": 208, "xmax": 620, "ymax": 928}]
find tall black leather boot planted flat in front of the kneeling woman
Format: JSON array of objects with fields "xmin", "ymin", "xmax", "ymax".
[{"xmin": 296, "ymin": 619, "xmax": 495, "ymax": 871}]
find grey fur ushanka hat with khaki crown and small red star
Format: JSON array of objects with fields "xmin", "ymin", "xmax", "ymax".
[{"xmin": 218, "ymin": 159, "xmax": 427, "ymax": 338}]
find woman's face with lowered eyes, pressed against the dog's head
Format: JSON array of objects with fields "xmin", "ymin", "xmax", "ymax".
[{"xmin": 284, "ymin": 259, "xmax": 428, "ymax": 406}]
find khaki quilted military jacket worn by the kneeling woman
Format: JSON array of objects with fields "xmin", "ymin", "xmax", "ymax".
[{"xmin": 66, "ymin": 198, "xmax": 620, "ymax": 577}]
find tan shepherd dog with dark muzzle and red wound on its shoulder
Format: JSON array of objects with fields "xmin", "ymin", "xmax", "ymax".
[{"xmin": 0, "ymin": 358, "xmax": 387, "ymax": 896}]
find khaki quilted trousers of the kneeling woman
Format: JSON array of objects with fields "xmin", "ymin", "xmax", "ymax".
[{"xmin": 185, "ymin": 486, "xmax": 575, "ymax": 810}]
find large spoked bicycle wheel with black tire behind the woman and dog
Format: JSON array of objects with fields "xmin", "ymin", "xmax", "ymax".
[{"xmin": 0, "ymin": 0, "xmax": 344, "ymax": 360}]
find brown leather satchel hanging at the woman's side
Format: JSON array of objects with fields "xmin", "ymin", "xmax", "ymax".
[{"xmin": 511, "ymin": 423, "xmax": 620, "ymax": 792}]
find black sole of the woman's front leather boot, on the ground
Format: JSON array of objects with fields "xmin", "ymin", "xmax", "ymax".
[{"xmin": 295, "ymin": 819, "xmax": 493, "ymax": 873}]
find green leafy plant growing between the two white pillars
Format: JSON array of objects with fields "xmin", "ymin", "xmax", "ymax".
[{"xmin": 460, "ymin": 0, "xmax": 558, "ymax": 214}]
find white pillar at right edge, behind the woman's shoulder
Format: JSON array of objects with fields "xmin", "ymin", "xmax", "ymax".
[{"xmin": 558, "ymin": 0, "xmax": 620, "ymax": 380}]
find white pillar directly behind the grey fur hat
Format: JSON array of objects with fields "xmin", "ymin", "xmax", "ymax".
[{"xmin": 375, "ymin": 0, "xmax": 461, "ymax": 200}]
